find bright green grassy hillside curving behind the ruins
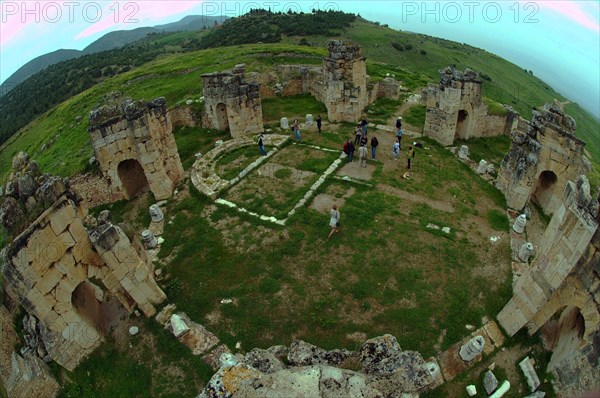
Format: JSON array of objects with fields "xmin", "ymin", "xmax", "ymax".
[{"xmin": 0, "ymin": 13, "xmax": 600, "ymax": 185}]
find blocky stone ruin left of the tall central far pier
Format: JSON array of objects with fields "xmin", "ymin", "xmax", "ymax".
[{"xmin": 202, "ymin": 64, "xmax": 264, "ymax": 138}]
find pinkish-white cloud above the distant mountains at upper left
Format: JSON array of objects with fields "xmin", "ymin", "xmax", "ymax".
[{"xmin": 75, "ymin": 0, "xmax": 202, "ymax": 39}]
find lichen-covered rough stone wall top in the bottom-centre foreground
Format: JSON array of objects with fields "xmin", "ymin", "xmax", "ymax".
[{"xmin": 198, "ymin": 335, "xmax": 441, "ymax": 398}]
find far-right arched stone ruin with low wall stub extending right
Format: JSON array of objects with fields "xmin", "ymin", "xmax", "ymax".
[{"xmin": 422, "ymin": 67, "xmax": 519, "ymax": 146}]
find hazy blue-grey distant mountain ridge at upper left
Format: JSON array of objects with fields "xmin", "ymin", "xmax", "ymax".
[{"xmin": 0, "ymin": 15, "xmax": 227, "ymax": 97}]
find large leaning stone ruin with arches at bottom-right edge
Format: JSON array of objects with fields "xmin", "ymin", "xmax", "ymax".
[{"xmin": 497, "ymin": 176, "xmax": 600, "ymax": 396}]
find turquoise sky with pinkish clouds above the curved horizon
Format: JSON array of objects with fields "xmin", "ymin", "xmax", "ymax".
[{"xmin": 0, "ymin": 0, "xmax": 600, "ymax": 117}]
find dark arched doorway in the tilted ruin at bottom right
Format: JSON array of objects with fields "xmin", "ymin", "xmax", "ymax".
[{"xmin": 540, "ymin": 305, "xmax": 585, "ymax": 371}]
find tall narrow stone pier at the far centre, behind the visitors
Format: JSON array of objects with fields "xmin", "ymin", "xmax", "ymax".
[{"xmin": 323, "ymin": 40, "xmax": 369, "ymax": 122}]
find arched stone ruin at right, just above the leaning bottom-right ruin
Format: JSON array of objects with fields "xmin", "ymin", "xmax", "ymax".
[{"xmin": 496, "ymin": 101, "xmax": 587, "ymax": 214}]
